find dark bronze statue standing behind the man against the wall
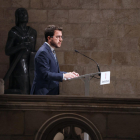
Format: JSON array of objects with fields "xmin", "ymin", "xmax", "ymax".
[{"xmin": 4, "ymin": 8, "xmax": 37, "ymax": 94}]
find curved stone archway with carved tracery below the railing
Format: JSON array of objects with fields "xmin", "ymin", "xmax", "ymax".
[{"xmin": 35, "ymin": 113, "xmax": 102, "ymax": 140}]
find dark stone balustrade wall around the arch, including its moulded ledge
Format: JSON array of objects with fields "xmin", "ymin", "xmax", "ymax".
[{"xmin": 0, "ymin": 95, "xmax": 140, "ymax": 140}]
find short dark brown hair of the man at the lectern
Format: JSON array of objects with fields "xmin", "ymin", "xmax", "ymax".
[{"xmin": 44, "ymin": 25, "xmax": 62, "ymax": 42}]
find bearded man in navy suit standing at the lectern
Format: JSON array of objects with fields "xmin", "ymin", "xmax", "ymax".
[{"xmin": 31, "ymin": 25, "xmax": 79, "ymax": 95}]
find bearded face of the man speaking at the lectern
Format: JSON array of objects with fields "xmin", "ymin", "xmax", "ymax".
[{"xmin": 50, "ymin": 30, "xmax": 63, "ymax": 48}]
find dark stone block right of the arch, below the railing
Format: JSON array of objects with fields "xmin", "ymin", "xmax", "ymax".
[{"xmin": 107, "ymin": 114, "xmax": 140, "ymax": 138}]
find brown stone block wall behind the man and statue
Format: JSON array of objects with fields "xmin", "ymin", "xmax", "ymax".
[{"xmin": 0, "ymin": 0, "xmax": 140, "ymax": 98}]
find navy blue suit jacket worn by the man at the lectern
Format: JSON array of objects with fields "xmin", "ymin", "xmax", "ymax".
[{"xmin": 30, "ymin": 43, "xmax": 65, "ymax": 95}]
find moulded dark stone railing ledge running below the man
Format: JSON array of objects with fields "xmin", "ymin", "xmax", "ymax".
[{"xmin": 0, "ymin": 94, "xmax": 140, "ymax": 113}]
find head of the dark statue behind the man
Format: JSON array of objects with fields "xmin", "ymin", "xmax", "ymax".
[{"xmin": 15, "ymin": 8, "xmax": 28, "ymax": 26}]
